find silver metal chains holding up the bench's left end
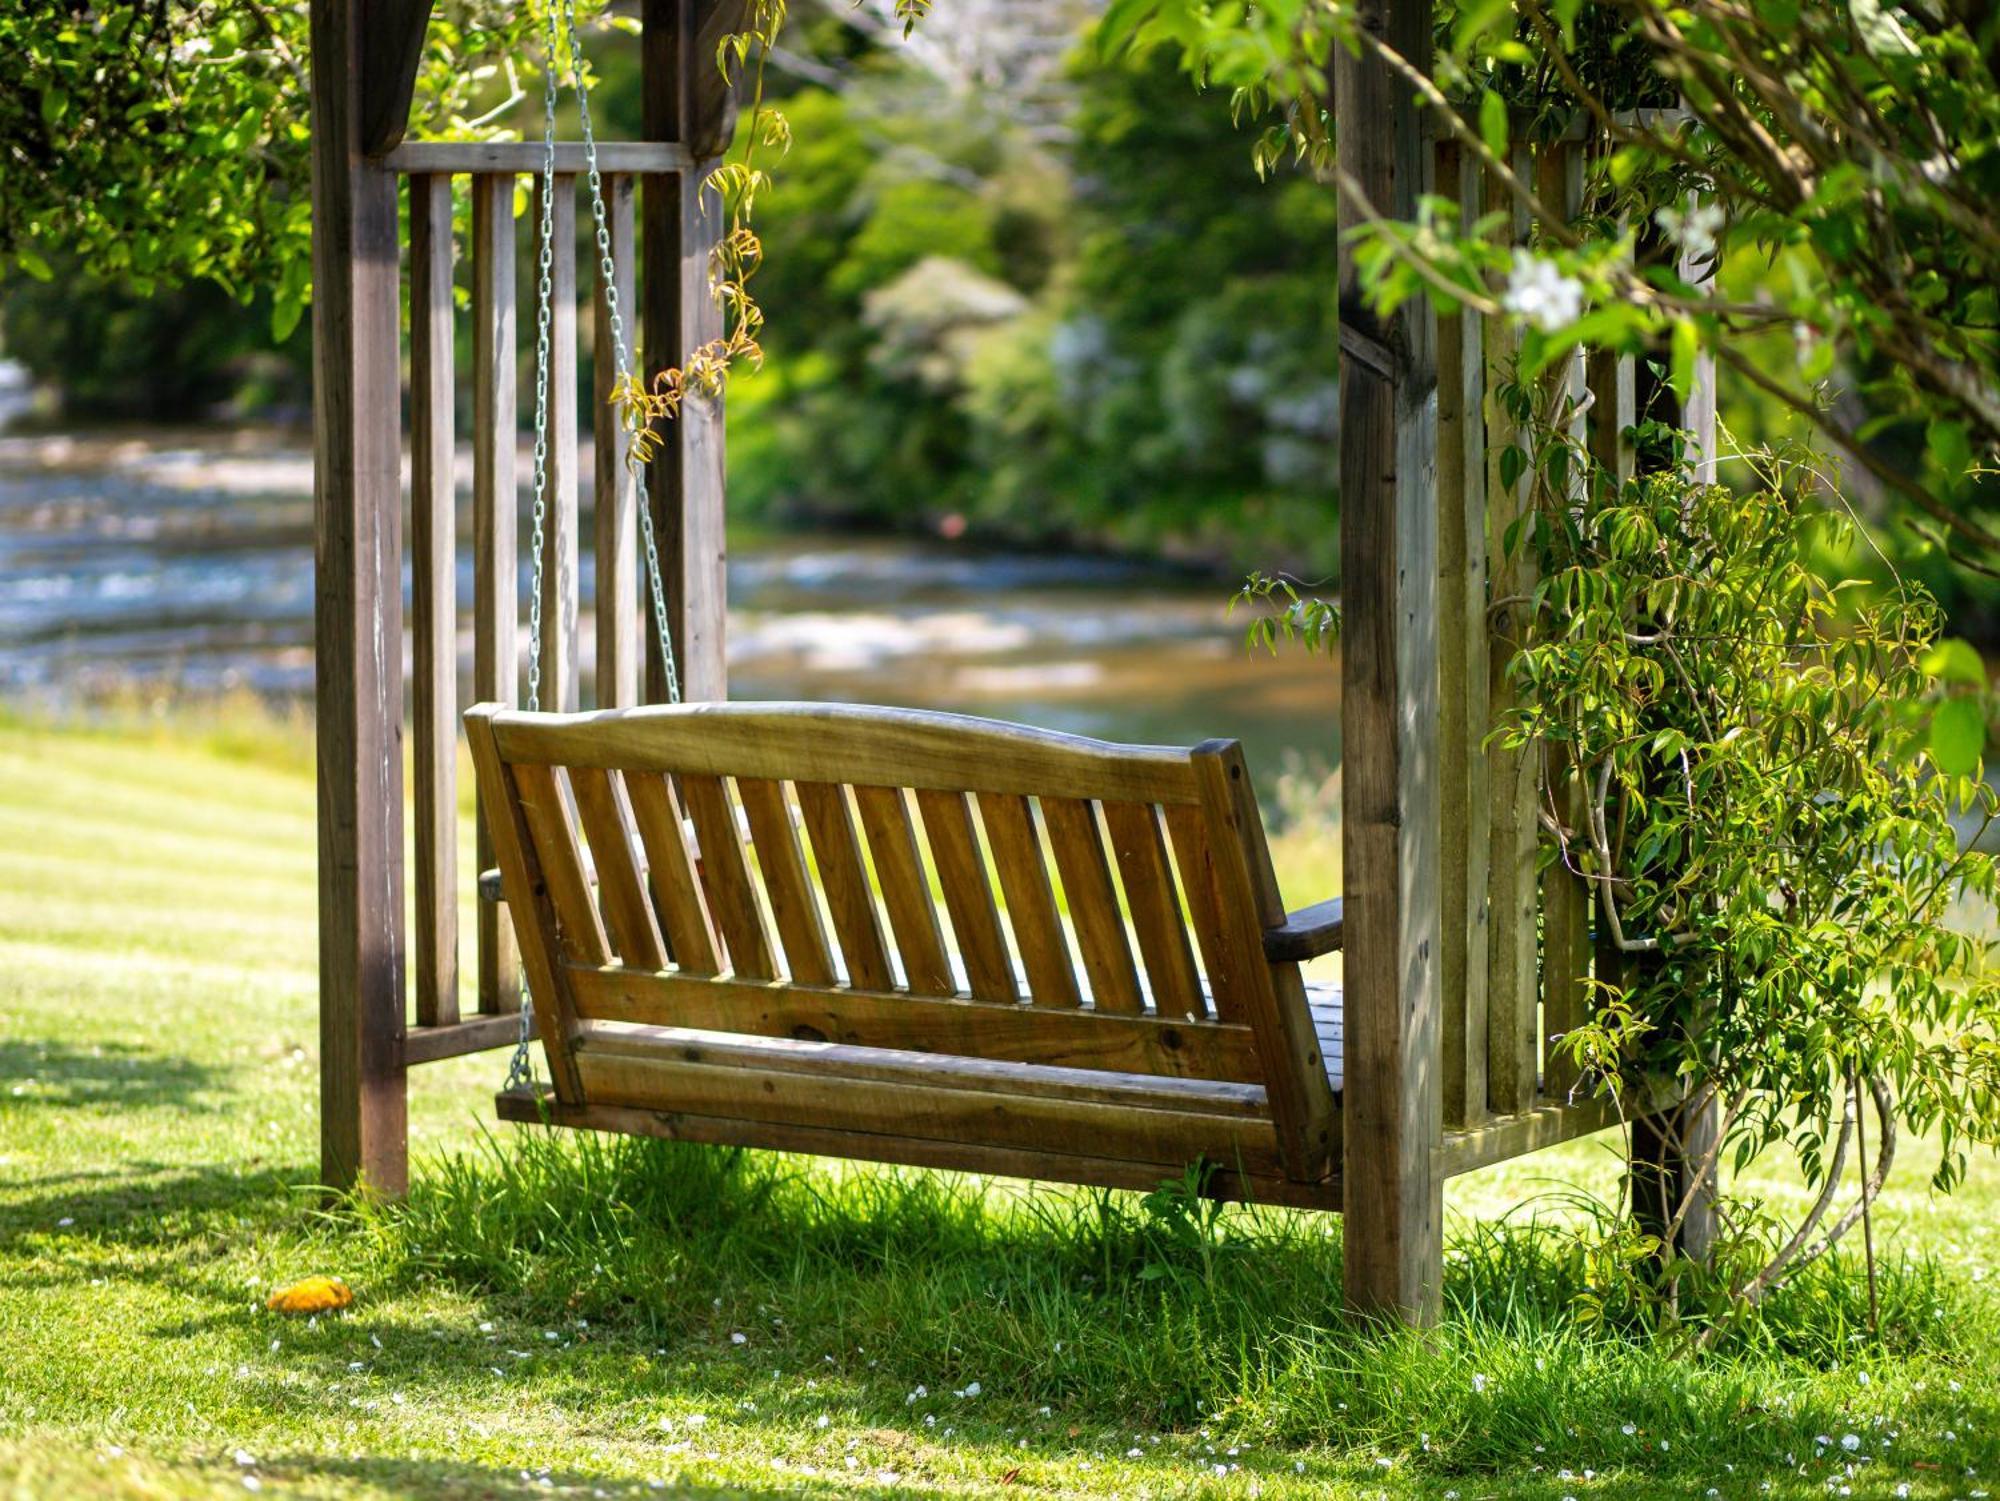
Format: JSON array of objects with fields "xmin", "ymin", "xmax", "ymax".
[{"xmin": 504, "ymin": 0, "xmax": 680, "ymax": 1091}]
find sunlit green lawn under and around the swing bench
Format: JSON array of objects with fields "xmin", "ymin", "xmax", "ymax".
[{"xmin": 0, "ymin": 712, "xmax": 2000, "ymax": 1501}]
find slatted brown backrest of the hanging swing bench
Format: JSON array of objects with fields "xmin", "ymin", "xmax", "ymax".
[{"xmin": 466, "ymin": 702, "xmax": 1332, "ymax": 1175}]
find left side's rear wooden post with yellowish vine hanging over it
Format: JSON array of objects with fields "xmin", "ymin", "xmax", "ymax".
[{"xmin": 640, "ymin": 0, "xmax": 742, "ymax": 700}]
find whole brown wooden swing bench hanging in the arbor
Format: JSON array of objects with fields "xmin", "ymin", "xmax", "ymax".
[{"xmin": 466, "ymin": 702, "xmax": 1342, "ymax": 1209}]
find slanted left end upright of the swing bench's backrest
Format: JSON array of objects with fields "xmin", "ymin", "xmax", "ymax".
[{"xmin": 466, "ymin": 706, "xmax": 584, "ymax": 1101}]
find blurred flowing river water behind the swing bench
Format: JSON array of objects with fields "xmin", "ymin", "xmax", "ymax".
[{"xmin": 0, "ymin": 432, "xmax": 1340, "ymax": 781}]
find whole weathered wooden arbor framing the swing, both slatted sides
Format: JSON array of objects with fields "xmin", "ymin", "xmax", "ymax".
[{"xmin": 312, "ymin": 0, "xmax": 1720, "ymax": 1319}]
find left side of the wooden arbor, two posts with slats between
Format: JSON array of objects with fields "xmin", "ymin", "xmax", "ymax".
[{"xmin": 312, "ymin": 0, "xmax": 736, "ymax": 1193}]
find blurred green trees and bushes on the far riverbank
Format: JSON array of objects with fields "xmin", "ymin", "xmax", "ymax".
[{"xmin": 0, "ymin": 0, "xmax": 1338, "ymax": 570}]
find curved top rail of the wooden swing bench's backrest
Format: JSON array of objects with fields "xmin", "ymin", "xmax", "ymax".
[{"xmin": 494, "ymin": 702, "xmax": 1194, "ymax": 805}]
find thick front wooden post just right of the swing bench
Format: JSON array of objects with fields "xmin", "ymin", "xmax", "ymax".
[{"xmin": 1334, "ymin": 0, "xmax": 1444, "ymax": 1321}]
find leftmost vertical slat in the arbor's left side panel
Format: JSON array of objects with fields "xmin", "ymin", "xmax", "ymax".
[{"xmin": 410, "ymin": 176, "xmax": 458, "ymax": 1027}]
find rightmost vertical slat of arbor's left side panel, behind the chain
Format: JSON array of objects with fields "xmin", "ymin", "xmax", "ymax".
[{"xmin": 590, "ymin": 174, "xmax": 644, "ymax": 708}]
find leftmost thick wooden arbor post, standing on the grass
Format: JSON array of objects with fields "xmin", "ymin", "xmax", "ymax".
[{"xmin": 312, "ymin": 0, "xmax": 408, "ymax": 1193}]
